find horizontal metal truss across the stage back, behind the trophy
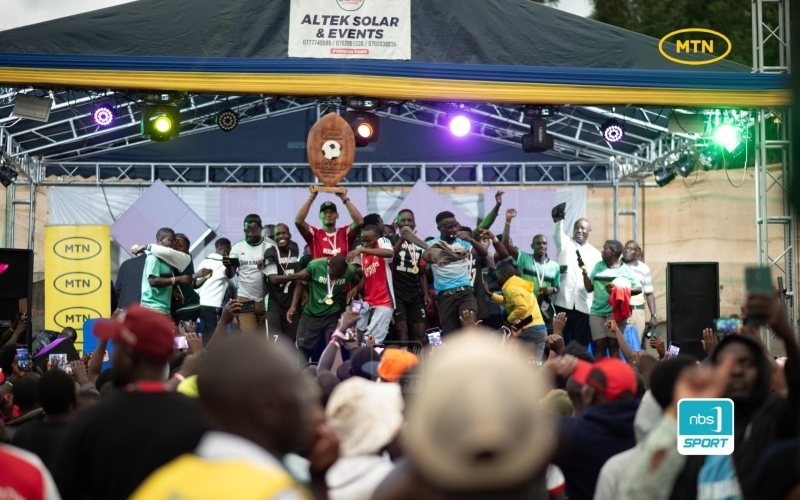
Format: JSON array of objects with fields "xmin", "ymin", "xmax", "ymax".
[{"xmin": 39, "ymin": 161, "xmax": 613, "ymax": 187}]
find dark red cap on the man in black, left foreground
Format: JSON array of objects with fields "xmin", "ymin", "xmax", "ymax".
[{"xmin": 94, "ymin": 304, "xmax": 175, "ymax": 361}]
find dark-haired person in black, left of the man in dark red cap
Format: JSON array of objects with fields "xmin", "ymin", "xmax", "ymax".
[{"xmin": 11, "ymin": 370, "xmax": 77, "ymax": 468}]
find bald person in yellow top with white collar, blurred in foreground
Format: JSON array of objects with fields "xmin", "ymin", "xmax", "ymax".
[{"xmin": 131, "ymin": 337, "xmax": 339, "ymax": 500}]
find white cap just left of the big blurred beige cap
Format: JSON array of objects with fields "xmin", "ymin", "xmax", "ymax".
[{"xmin": 325, "ymin": 377, "xmax": 404, "ymax": 457}]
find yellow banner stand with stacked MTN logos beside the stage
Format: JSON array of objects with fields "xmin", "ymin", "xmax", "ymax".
[{"xmin": 44, "ymin": 226, "xmax": 111, "ymax": 353}]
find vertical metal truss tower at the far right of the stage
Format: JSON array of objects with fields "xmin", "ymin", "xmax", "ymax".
[{"xmin": 752, "ymin": 0, "xmax": 800, "ymax": 346}]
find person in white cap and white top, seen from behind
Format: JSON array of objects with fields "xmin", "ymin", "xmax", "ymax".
[{"xmin": 325, "ymin": 378, "xmax": 408, "ymax": 500}]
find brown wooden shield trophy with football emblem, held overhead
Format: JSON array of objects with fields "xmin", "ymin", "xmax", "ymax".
[{"xmin": 306, "ymin": 113, "xmax": 356, "ymax": 193}]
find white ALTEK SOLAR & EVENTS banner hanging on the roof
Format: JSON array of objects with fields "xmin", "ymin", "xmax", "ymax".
[{"xmin": 289, "ymin": 0, "xmax": 411, "ymax": 59}]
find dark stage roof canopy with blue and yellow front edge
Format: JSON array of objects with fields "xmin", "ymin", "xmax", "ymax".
[{"xmin": 0, "ymin": 0, "xmax": 790, "ymax": 107}]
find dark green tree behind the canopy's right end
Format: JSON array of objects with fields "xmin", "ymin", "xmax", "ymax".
[{"xmin": 590, "ymin": 0, "xmax": 778, "ymax": 66}]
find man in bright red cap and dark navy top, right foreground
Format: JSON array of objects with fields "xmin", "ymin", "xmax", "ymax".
[{"xmin": 553, "ymin": 358, "xmax": 639, "ymax": 500}]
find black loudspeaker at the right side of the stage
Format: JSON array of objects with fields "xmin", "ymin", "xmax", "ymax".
[{"xmin": 667, "ymin": 262, "xmax": 719, "ymax": 351}]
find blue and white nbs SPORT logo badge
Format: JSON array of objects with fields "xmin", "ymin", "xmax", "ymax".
[{"xmin": 678, "ymin": 398, "xmax": 733, "ymax": 455}]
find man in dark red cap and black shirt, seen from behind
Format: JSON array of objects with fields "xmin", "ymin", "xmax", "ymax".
[{"xmin": 52, "ymin": 305, "xmax": 206, "ymax": 500}]
